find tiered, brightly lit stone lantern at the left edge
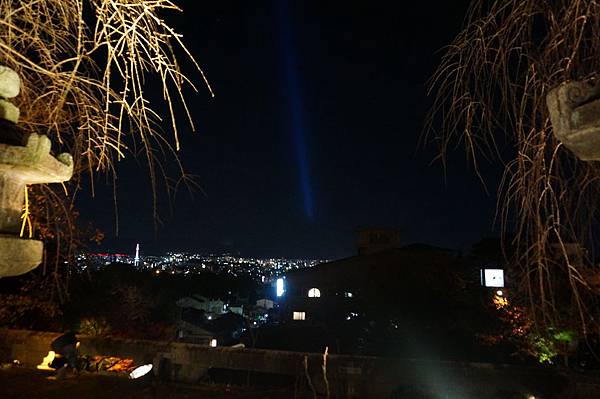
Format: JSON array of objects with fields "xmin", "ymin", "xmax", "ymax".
[{"xmin": 0, "ymin": 66, "xmax": 73, "ymax": 278}]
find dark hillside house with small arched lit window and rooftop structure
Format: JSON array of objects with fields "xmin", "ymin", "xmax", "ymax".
[{"xmin": 279, "ymin": 236, "xmax": 457, "ymax": 325}]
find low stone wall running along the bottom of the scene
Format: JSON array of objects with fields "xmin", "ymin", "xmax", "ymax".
[{"xmin": 0, "ymin": 330, "xmax": 600, "ymax": 399}]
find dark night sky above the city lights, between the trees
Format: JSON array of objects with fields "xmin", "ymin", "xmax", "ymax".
[{"xmin": 80, "ymin": 0, "xmax": 499, "ymax": 258}]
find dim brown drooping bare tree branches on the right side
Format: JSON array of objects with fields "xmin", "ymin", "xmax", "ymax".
[{"xmin": 426, "ymin": 0, "xmax": 600, "ymax": 340}]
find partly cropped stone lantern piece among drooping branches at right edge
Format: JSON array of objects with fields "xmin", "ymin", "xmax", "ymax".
[{"xmin": 546, "ymin": 80, "xmax": 600, "ymax": 161}]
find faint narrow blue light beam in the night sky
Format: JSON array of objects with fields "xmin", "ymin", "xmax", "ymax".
[{"xmin": 276, "ymin": 0, "xmax": 315, "ymax": 221}]
